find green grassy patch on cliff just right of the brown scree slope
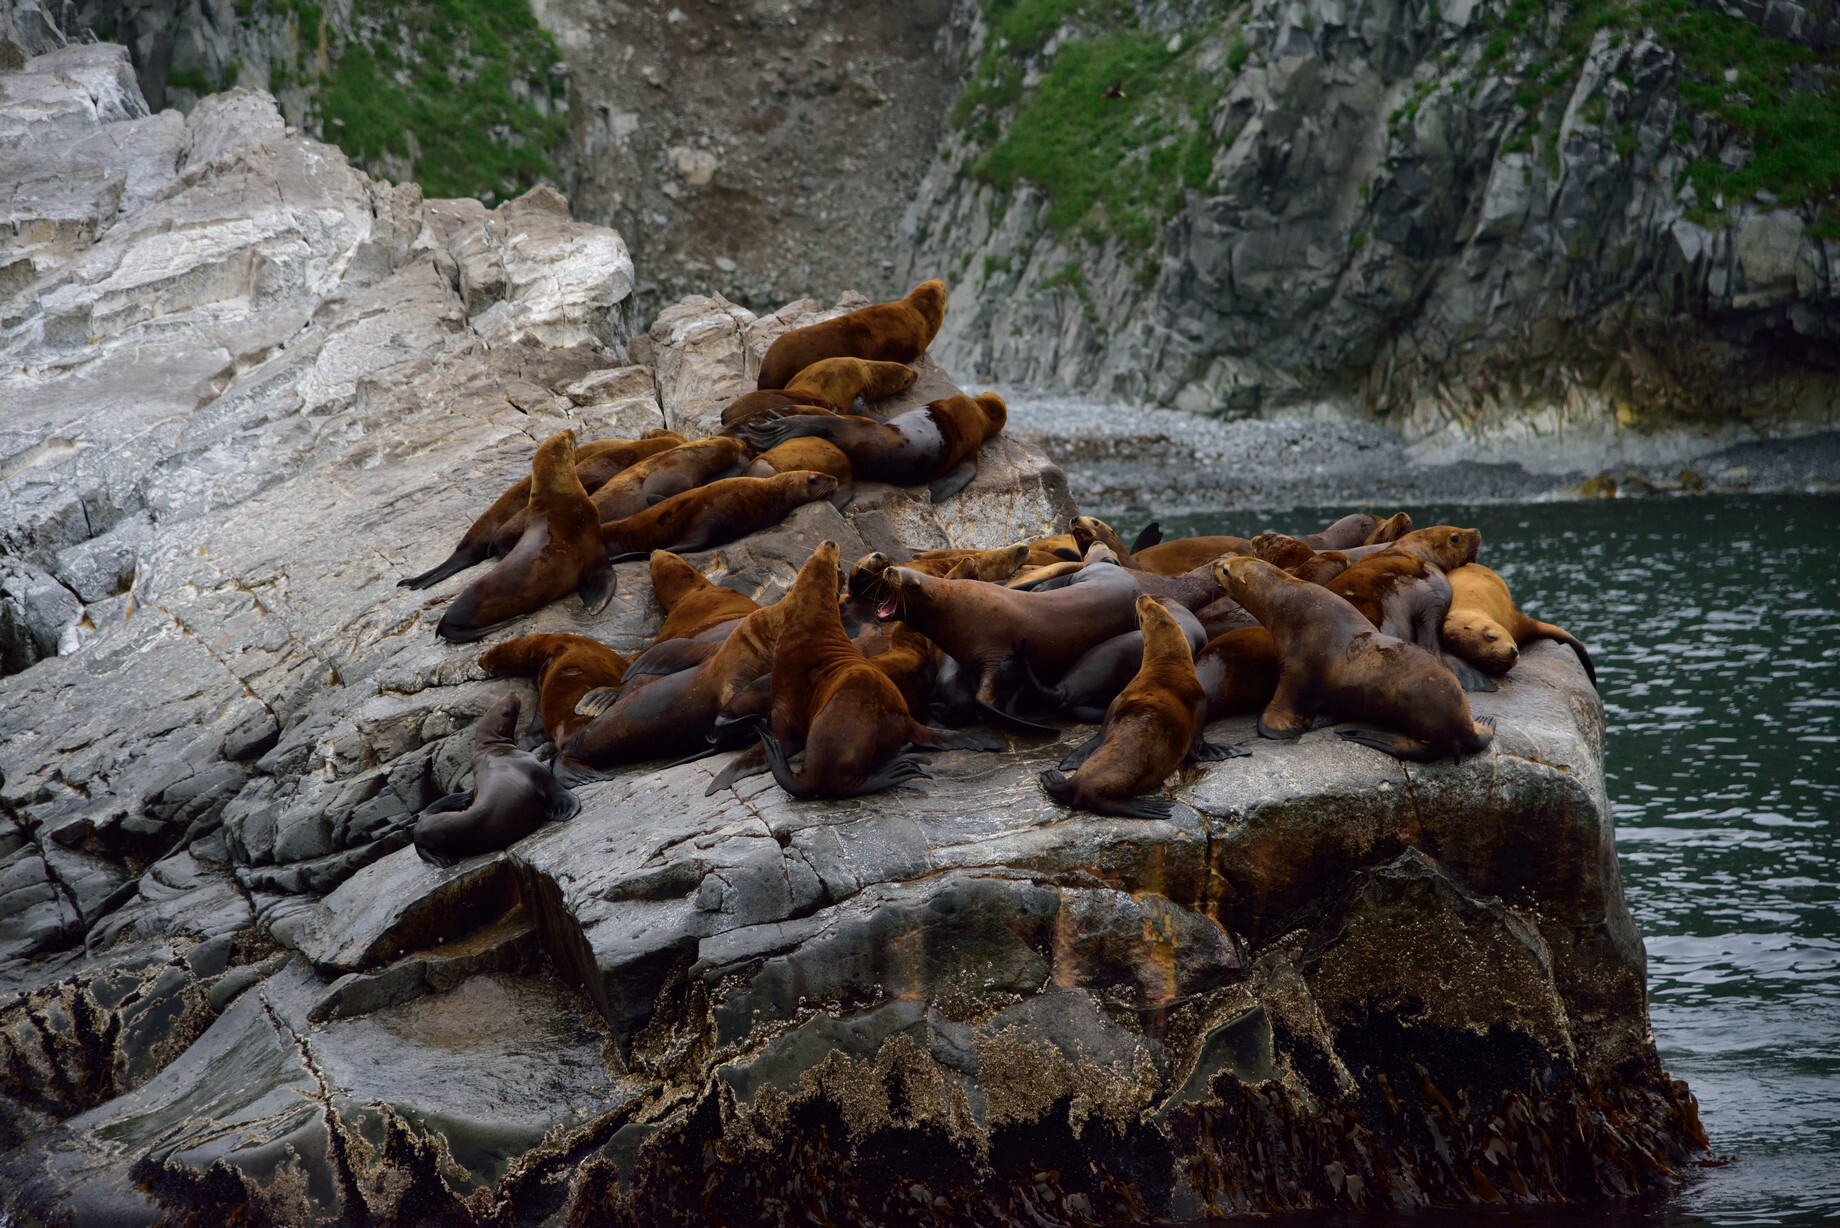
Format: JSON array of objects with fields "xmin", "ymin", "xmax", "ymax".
[{"xmin": 951, "ymin": 0, "xmax": 1246, "ymax": 249}]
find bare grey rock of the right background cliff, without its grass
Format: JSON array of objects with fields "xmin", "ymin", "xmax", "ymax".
[{"xmin": 896, "ymin": 0, "xmax": 1840, "ymax": 473}]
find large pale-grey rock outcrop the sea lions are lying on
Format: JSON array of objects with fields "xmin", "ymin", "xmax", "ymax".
[{"xmin": 0, "ymin": 46, "xmax": 1704, "ymax": 1226}]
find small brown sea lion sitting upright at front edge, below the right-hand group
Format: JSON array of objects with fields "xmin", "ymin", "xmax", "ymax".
[{"xmin": 1041, "ymin": 597, "xmax": 1248, "ymax": 819}]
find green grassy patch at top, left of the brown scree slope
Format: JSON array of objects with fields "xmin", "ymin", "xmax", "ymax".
[{"xmin": 316, "ymin": 0, "xmax": 567, "ymax": 201}]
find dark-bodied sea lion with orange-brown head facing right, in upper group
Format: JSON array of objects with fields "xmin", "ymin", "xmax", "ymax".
[{"xmin": 742, "ymin": 392, "xmax": 1008, "ymax": 503}]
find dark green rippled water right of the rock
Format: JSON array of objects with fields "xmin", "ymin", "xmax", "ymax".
[{"xmin": 1121, "ymin": 495, "xmax": 1840, "ymax": 1228}]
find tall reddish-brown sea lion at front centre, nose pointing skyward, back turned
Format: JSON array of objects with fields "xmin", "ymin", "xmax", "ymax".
[{"xmin": 760, "ymin": 541, "xmax": 1001, "ymax": 797}]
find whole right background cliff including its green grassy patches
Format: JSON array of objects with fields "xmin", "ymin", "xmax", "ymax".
[{"xmin": 898, "ymin": 0, "xmax": 1840, "ymax": 473}]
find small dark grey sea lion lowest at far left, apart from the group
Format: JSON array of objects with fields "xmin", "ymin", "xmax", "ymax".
[{"xmin": 414, "ymin": 690, "xmax": 581, "ymax": 865}]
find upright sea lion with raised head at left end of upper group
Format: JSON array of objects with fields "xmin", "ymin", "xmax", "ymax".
[{"xmin": 434, "ymin": 431, "xmax": 613, "ymax": 643}]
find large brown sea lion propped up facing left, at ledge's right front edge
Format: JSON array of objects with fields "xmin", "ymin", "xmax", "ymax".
[{"xmin": 1214, "ymin": 558, "xmax": 1494, "ymax": 762}]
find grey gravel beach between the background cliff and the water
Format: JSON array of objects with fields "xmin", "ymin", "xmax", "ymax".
[{"xmin": 997, "ymin": 388, "xmax": 1840, "ymax": 516}]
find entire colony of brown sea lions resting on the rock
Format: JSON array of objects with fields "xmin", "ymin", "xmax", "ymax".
[{"xmin": 403, "ymin": 284, "xmax": 1590, "ymax": 860}]
